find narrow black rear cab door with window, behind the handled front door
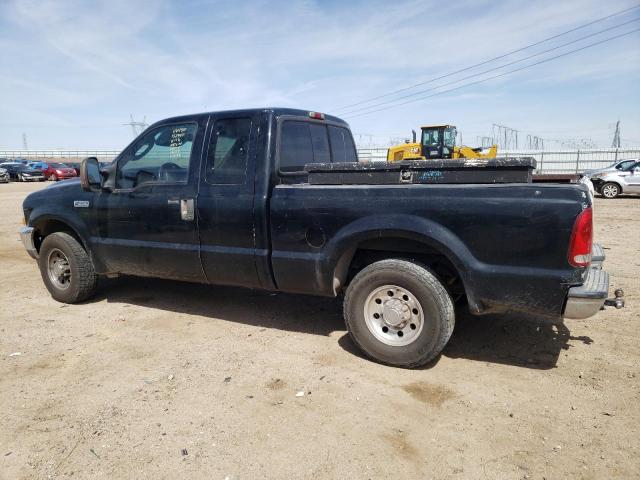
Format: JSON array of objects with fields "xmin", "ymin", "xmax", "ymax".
[{"xmin": 198, "ymin": 113, "xmax": 264, "ymax": 287}]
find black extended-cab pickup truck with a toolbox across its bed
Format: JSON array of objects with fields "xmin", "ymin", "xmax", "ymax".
[{"xmin": 21, "ymin": 108, "xmax": 622, "ymax": 367}]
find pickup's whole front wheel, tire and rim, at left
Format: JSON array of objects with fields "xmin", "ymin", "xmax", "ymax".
[{"xmin": 38, "ymin": 232, "xmax": 98, "ymax": 303}]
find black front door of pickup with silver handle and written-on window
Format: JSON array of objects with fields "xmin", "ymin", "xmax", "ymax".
[{"xmin": 96, "ymin": 116, "xmax": 208, "ymax": 282}]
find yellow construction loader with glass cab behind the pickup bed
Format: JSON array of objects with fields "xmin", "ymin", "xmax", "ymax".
[{"xmin": 387, "ymin": 125, "xmax": 498, "ymax": 162}]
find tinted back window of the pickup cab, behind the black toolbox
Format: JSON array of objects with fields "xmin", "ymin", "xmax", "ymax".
[{"xmin": 280, "ymin": 120, "xmax": 358, "ymax": 172}]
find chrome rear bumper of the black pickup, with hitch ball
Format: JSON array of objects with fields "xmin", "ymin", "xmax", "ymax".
[{"xmin": 562, "ymin": 244, "xmax": 624, "ymax": 319}]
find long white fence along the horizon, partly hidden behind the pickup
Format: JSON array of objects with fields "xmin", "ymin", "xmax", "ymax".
[{"xmin": 0, "ymin": 148, "xmax": 640, "ymax": 174}]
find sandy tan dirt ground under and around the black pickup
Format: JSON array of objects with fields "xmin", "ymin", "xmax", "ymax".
[{"xmin": 0, "ymin": 184, "xmax": 640, "ymax": 480}]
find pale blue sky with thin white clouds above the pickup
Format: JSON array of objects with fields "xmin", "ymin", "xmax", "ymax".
[{"xmin": 0, "ymin": 0, "xmax": 640, "ymax": 150}]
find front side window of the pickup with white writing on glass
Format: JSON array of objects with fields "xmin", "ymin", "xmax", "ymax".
[{"xmin": 116, "ymin": 123, "xmax": 196, "ymax": 189}]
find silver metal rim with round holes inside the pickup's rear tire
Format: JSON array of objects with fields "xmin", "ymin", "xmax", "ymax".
[{"xmin": 364, "ymin": 285, "xmax": 424, "ymax": 347}]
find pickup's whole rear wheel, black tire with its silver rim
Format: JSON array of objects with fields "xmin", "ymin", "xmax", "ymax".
[{"xmin": 344, "ymin": 259, "xmax": 455, "ymax": 368}]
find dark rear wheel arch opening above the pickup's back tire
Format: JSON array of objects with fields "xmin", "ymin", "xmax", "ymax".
[{"xmin": 334, "ymin": 237, "xmax": 466, "ymax": 298}]
